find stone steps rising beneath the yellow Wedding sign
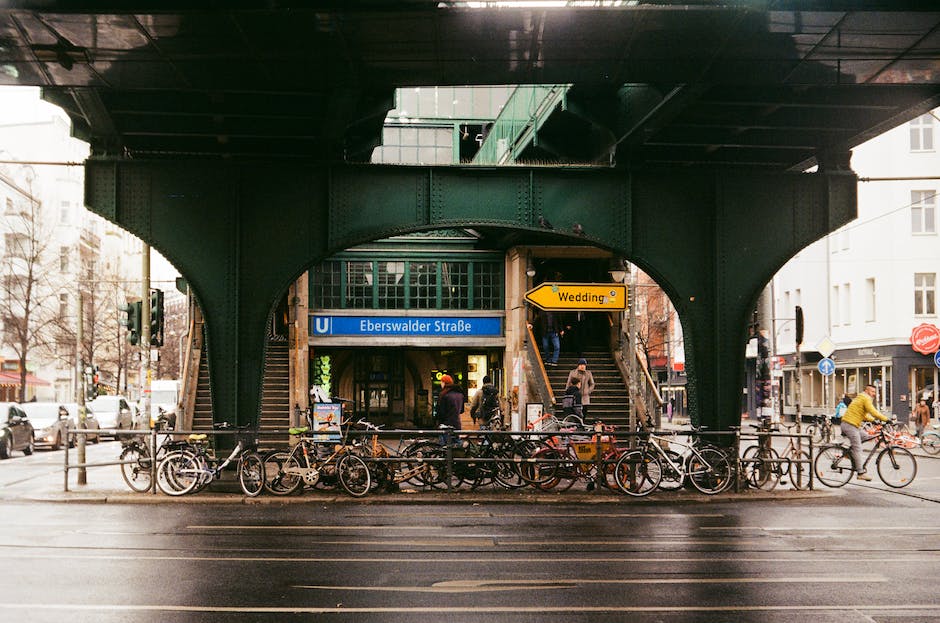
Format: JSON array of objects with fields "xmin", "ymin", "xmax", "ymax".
[{"xmin": 545, "ymin": 351, "xmax": 630, "ymax": 426}]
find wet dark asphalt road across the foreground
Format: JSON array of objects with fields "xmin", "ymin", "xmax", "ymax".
[{"xmin": 0, "ymin": 445, "xmax": 940, "ymax": 623}]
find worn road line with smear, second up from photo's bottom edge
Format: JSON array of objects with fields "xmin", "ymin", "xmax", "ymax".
[{"xmin": 291, "ymin": 575, "xmax": 890, "ymax": 593}]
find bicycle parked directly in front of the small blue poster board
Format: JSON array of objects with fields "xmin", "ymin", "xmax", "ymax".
[{"xmin": 262, "ymin": 426, "xmax": 372, "ymax": 498}]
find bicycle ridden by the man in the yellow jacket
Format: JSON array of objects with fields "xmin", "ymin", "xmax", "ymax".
[{"xmin": 813, "ymin": 426, "xmax": 917, "ymax": 489}]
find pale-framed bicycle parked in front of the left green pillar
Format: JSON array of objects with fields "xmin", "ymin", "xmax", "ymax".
[{"xmin": 157, "ymin": 424, "xmax": 264, "ymax": 497}]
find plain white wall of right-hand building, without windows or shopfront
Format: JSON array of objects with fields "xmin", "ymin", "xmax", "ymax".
[{"xmin": 773, "ymin": 111, "xmax": 940, "ymax": 417}]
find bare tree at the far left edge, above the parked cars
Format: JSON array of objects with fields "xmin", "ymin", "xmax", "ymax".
[{"xmin": 0, "ymin": 179, "xmax": 59, "ymax": 402}]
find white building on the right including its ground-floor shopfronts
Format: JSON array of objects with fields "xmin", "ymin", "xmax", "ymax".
[{"xmin": 768, "ymin": 110, "xmax": 940, "ymax": 420}]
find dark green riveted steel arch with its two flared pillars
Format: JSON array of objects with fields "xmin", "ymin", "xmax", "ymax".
[{"xmin": 86, "ymin": 159, "xmax": 856, "ymax": 428}]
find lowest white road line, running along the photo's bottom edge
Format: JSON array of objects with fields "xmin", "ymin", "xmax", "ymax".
[{"xmin": 0, "ymin": 603, "xmax": 940, "ymax": 614}]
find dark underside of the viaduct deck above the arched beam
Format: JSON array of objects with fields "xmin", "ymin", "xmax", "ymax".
[{"xmin": 0, "ymin": 0, "xmax": 940, "ymax": 170}]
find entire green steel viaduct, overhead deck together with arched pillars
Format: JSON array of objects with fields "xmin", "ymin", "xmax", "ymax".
[{"xmin": 0, "ymin": 0, "xmax": 940, "ymax": 434}]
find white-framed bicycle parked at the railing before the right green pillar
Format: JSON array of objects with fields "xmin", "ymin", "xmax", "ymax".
[{"xmin": 614, "ymin": 430, "xmax": 734, "ymax": 497}]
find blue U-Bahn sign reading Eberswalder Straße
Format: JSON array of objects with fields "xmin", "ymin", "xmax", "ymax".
[{"xmin": 310, "ymin": 315, "xmax": 503, "ymax": 337}]
